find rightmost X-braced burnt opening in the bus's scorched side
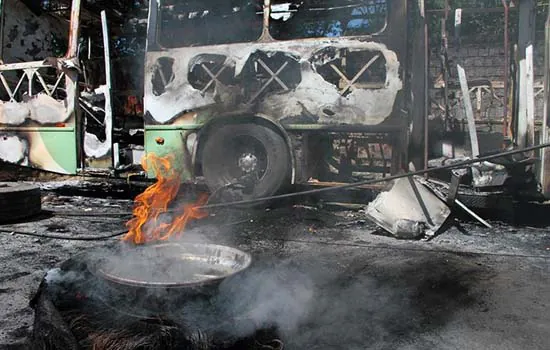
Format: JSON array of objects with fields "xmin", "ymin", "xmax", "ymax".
[{"xmin": 311, "ymin": 47, "xmax": 387, "ymax": 96}]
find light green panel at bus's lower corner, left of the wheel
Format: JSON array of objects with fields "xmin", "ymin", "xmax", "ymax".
[{"xmin": 145, "ymin": 129, "xmax": 192, "ymax": 181}]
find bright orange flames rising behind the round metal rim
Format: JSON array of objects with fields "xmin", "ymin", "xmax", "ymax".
[{"xmin": 123, "ymin": 153, "xmax": 208, "ymax": 244}]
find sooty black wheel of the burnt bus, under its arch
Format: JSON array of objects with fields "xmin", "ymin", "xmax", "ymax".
[{"xmin": 201, "ymin": 123, "xmax": 291, "ymax": 200}]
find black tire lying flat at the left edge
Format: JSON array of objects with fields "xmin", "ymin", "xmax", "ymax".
[{"xmin": 0, "ymin": 182, "xmax": 42, "ymax": 222}]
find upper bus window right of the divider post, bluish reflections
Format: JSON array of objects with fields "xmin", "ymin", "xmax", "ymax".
[{"xmin": 269, "ymin": 0, "xmax": 387, "ymax": 40}]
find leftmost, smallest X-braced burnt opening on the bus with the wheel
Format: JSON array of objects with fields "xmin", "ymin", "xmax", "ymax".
[{"xmin": 187, "ymin": 54, "xmax": 235, "ymax": 93}]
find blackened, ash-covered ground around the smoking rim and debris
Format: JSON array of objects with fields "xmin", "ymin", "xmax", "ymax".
[{"xmin": 0, "ymin": 181, "xmax": 550, "ymax": 350}]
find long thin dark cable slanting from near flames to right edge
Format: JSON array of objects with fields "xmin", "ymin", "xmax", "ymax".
[{"xmin": 196, "ymin": 143, "xmax": 550, "ymax": 209}]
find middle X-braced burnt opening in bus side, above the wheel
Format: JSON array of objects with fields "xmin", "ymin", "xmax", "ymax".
[{"xmin": 240, "ymin": 51, "xmax": 302, "ymax": 103}]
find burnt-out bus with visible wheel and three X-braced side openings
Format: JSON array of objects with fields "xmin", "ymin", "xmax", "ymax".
[{"xmin": 144, "ymin": 0, "xmax": 408, "ymax": 198}]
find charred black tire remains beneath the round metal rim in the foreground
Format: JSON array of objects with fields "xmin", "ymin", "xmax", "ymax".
[{"xmin": 30, "ymin": 255, "xmax": 283, "ymax": 350}]
